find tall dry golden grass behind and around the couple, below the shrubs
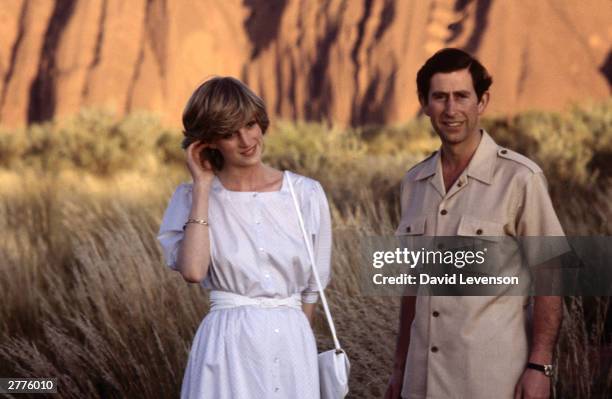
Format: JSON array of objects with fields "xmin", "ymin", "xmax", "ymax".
[{"xmin": 0, "ymin": 104, "xmax": 612, "ymax": 399}]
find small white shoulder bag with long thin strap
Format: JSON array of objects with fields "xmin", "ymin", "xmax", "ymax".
[{"xmin": 286, "ymin": 173, "xmax": 351, "ymax": 399}]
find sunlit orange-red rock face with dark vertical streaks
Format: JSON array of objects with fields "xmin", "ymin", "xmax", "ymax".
[{"xmin": 0, "ymin": 0, "xmax": 612, "ymax": 126}]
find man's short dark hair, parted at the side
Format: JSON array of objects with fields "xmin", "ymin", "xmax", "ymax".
[{"xmin": 417, "ymin": 48, "xmax": 493, "ymax": 104}]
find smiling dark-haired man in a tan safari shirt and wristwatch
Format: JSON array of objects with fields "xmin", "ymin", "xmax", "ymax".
[{"xmin": 385, "ymin": 48, "xmax": 563, "ymax": 399}]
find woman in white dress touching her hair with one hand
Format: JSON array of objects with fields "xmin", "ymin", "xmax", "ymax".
[{"xmin": 158, "ymin": 77, "xmax": 331, "ymax": 399}]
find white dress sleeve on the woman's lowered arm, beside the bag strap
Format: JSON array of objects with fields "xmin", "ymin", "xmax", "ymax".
[{"xmin": 302, "ymin": 182, "xmax": 332, "ymax": 303}]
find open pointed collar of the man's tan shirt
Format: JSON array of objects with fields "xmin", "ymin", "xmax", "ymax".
[{"xmin": 415, "ymin": 129, "xmax": 498, "ymax": 184}]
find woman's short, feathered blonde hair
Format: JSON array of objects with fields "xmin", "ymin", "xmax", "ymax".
[{"xmin": 182, "ymin": 76, "xmax": 270, "ymax": 170}]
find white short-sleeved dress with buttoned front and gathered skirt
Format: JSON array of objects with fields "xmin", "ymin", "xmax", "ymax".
[{"xmin": 158, "ymin": 172, "xmax": 331, "ymax": 399}]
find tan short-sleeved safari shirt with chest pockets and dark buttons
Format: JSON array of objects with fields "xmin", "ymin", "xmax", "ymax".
[{"xmin": 396, "ymin": 130, "xmax": 564, "ymax": 399}]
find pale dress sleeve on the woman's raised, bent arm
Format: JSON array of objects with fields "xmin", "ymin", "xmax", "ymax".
[{"xmin": 157, "ymin": 184, "xmax": 191, "ymax": 270}]
